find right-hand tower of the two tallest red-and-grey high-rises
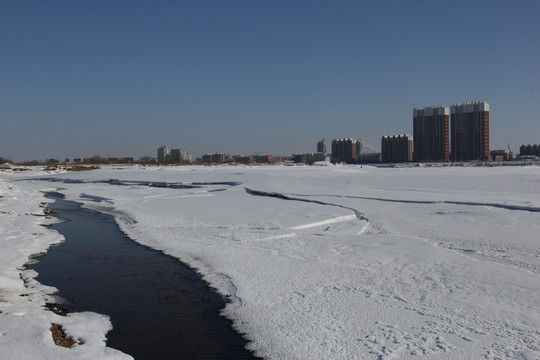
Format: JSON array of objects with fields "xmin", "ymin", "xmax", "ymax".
[{"xmin": 450, "ymin": 101, "xmax": 489, "ymax": 161}]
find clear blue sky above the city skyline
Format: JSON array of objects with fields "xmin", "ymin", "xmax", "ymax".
[{"xmin": 0, "ymin": 0, "xmax": 540, "ymax": 161}]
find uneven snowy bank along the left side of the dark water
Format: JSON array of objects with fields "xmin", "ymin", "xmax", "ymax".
[{"xmin": 0, "ymin": 172, "xmax": 130, "ymax": 359}]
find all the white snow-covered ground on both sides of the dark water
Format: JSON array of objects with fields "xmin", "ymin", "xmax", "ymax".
[{"xmin": 0, "ymin": 166, "xmax": 540, "ymax": 359}]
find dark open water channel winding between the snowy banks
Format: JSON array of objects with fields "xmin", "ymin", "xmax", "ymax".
[{"xmin": 28, "ymin": 193, "xmax": 256, "ymax": 360}]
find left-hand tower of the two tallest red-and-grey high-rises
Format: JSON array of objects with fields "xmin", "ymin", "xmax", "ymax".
[{"xmin": 413, "ymin": 106, "xmax": 450, "ymax": 162}]
